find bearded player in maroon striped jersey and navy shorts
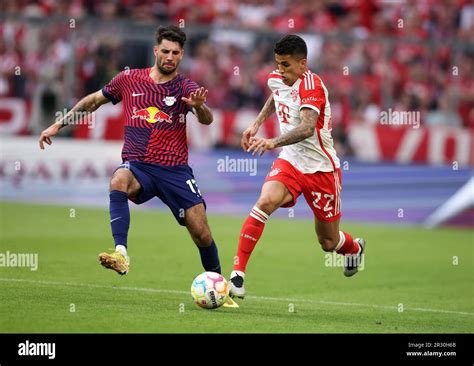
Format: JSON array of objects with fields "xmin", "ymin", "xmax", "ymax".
[{"xmin": 39, "ymin": 26, "xmax": 221, "ymax": 275}]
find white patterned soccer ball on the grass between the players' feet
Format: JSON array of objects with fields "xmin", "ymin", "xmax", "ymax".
[{"xmin": 191, "ymin": 272, "xmax": 229, "ymax": 309}]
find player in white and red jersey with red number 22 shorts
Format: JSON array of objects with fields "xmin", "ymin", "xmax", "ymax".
[{"xmin": 230, "ymin": 35, "xmax": 365, "ymax": 298}]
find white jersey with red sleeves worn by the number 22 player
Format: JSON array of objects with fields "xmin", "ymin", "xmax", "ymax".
[{"xmin": 268, "ymin": 70, "xmax": 340, "ymax": 174}]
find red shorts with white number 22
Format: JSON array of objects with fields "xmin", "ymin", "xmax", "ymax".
[{"xmin": 265, "ymin": 158, "xmax": 342, "ymax": 222}]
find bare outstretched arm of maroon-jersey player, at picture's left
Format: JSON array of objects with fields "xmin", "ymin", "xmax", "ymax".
[{"xmin": 39, "ymin": 90, "xmax": 110, "ymax": 150}]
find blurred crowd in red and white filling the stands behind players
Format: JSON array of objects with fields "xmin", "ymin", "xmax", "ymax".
[{"xmin": 0, "ymin": 0, "xmax": 474, "ymax": 141}]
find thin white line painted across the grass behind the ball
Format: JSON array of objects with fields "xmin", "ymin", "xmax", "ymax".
[{"xmin": 0, "ymin": 278, "xmax": 474, "ymax": 316}]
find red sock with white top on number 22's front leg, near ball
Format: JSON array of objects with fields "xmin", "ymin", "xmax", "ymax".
[{"xmin": 234, "ymin": 206, "xmax": 268, "ymax": 272}]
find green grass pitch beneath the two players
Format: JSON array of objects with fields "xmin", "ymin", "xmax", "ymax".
[{"xmin": 0, "ymin": 203, "xmax": 474, "ymax": 333}]
